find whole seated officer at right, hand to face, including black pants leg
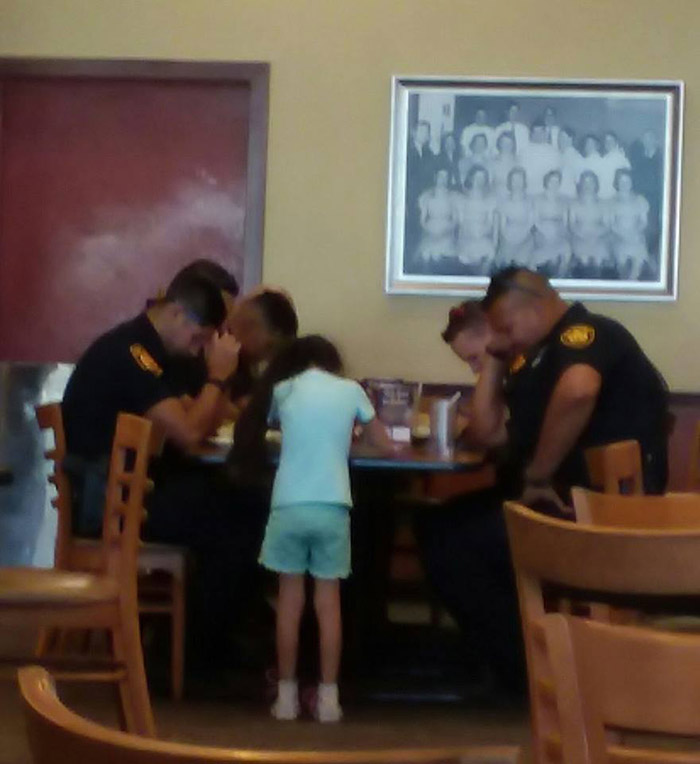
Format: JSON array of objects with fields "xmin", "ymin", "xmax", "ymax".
[{"xmin": 420, "ymin": 268, "xmax": 667, "ymax": 690}]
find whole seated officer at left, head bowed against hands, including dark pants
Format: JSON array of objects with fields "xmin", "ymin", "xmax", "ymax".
[{"xmin": 63, "ymin": 273, "xmax": 264, "ymax": 668}]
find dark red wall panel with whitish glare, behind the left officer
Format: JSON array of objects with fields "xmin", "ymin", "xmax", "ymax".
[{"xmin": 0, "ymin": 78, "xmax": 250, "ymax": 362}]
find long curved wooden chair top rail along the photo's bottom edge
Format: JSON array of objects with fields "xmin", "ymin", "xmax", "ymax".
[{"xmin": 19, "ymin": 666, "xmax": 519, "ymax": 764}]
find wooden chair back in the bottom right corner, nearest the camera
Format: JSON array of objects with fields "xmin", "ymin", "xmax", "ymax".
[{"xmin": 541, "ymin": 614, "xmax": 700, "ymax": 764}]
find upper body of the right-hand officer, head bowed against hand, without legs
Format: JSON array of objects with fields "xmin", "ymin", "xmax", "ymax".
[{"xmin": 472, "ymin": 268, "xmax": 668, "ymax": 504}]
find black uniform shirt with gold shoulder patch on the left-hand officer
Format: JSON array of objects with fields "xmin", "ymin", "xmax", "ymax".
[{"xmin": 62, "ymin": 313, "xmax": 180, "ymax": 461}]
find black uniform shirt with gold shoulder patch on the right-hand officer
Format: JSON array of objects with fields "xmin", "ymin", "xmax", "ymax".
[{"xmin": 505, "ymin": 303, "xmax": 668, "ymax": 492}]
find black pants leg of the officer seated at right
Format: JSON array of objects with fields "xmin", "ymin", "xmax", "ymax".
[{"xmin": 417, "ymin": 489, "xmax": 525, "ymax": 692}]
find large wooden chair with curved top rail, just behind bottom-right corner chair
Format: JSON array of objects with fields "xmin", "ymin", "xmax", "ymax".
[{"xmin": 505, "ymin": 497, "xmax": 700, "ymax": 764}]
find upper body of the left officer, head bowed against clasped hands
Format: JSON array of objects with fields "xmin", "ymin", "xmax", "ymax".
[{"xmin": 63, "ymin": 274, "xmax": 239, "ymax": 533}]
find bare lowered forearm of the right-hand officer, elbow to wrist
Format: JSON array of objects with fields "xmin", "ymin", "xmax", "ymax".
[{"xmin": 525, "ymin": 395, "xmax": 596, "ymax": 483}]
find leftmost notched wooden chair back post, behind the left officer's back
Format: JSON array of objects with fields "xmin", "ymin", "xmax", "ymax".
[{"xmin": 35, "ymin": 403, "xmax": 72, "ymax": 569}]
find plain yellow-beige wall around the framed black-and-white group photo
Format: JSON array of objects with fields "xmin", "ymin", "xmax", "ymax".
[{"xmin": 0, "ymin": 0, "xmax": 700, "ymax": 390}]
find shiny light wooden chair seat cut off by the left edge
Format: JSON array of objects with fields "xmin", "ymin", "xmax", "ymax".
[{"xmin": 0, "ymin": 568, "xmax": 119, "ymax": 607}]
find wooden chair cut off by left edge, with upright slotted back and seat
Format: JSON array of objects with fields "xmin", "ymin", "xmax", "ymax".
[{"xmin": 0, "ymin": 414, "xmax": 155, "ymax": 736}]
